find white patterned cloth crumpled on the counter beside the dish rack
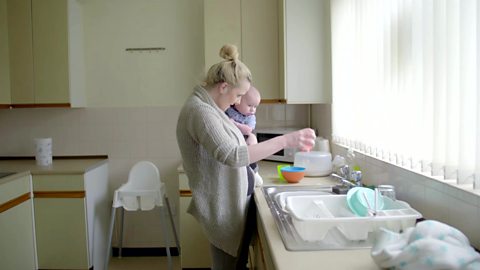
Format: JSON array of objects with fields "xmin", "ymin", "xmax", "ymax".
[{"xmin": 371, "ymin": 220, "xmax": 480, "ymax": 270}]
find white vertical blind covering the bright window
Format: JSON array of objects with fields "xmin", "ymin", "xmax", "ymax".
[{"xmin": 331, "ymin": 0, "xmax": 480, "ymax": 189}]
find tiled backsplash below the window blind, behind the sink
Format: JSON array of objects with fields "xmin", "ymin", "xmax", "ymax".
[{"xmin": 332, "ymin": 144, "xmax": 480, "ymax": 249}]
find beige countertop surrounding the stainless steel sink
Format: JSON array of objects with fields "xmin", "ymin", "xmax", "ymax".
[{"xmin": 255, "ymin": 161, "xmax": 379, "ymax": 270}]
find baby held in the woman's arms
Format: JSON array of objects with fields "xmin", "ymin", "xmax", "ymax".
[{"xmin": 225, "ymin": 86, "xmax": 263, "ymax": 186}]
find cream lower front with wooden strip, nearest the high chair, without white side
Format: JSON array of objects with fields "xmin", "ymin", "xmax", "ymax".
[{"xmin": 33, "ymin": 174, "xmax": 90, "ymax": 269}]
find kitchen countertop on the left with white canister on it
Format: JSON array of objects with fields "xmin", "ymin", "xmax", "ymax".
[{"xmin": 0, "ymin": 155, "xmax": 108, "ymax": 177}]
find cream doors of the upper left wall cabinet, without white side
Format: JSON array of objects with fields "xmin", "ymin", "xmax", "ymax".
[{"xmin": 7, "ymin": 0, "xmax": 70, "ymax": 105}]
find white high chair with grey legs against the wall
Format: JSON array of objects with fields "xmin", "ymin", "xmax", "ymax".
[{"xmin": 105, "ymin": 161, "xmax": 180, "ymax": 270}]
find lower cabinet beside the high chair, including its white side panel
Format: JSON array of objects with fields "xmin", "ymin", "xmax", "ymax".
[{"xmin": 33, "ymin": 163, "xmax": 111, "ymax": 269}]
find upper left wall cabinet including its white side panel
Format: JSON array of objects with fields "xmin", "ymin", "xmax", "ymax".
[{"xmin": 7, "ymin": 0, "xmax": 85, "ymax": 107}]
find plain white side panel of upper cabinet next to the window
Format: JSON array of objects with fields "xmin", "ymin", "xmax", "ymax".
[{"xmin": 279, "ymin": 0, "xmax": 332, "ymax": 104}]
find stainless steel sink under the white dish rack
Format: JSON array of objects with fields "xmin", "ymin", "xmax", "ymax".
[{"xmin": 262, "ymin": 185, "xmax": 373, "ymax": 251}]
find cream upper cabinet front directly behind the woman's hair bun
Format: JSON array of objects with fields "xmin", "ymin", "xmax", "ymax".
[{"xmin": 204, "ymin": 0, "xmax": 282, "ymax": 102}]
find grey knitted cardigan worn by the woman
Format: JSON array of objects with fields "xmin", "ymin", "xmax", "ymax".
[{"xmin": 177, "ymin": 86, "xmax": 249, "ymax": 257}]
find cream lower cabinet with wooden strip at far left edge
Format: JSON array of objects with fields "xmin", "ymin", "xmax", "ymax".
[{"xmin": 0, "ymin": 173, "xmax": 37, "ymax": 270}]
